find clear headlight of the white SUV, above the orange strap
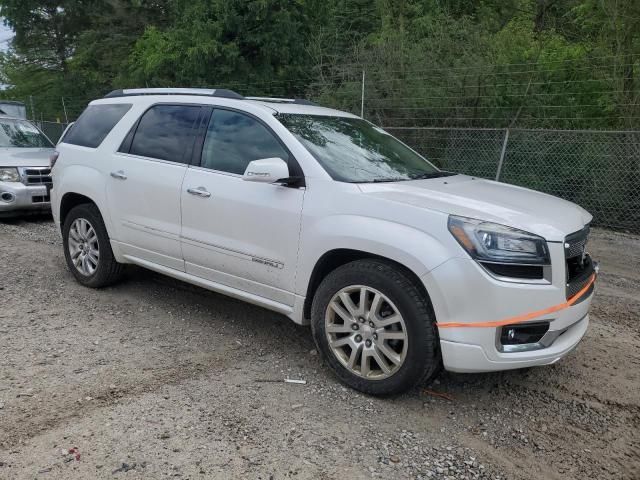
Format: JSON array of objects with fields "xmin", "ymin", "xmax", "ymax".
[{"xmin": 449, "ymin": 215, "xmax": 551, "ymax": 265}]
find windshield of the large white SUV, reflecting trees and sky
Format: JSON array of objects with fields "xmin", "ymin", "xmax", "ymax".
[{"xmin": 277, "ymin": 114, "xmax": 449, "ymax": 183}]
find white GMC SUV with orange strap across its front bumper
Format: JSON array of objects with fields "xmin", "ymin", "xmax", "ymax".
[{"xmin": 51, "ymin": 89, "xmax": 597, "ymax": 394}]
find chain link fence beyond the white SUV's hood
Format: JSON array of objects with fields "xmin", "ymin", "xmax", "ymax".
[{"xmin": 387, "ymin": 127, "xmax": 640, "ymax": 233}]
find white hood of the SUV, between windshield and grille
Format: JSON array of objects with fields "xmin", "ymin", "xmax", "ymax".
[{"xmin": 359, "ymin": 175, "xmax": 592, "ymax": 242}]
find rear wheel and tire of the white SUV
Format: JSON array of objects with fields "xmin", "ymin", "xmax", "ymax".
[{"xmin": 62, "ymin": 203, "xmax": 124, "ymax": 288}]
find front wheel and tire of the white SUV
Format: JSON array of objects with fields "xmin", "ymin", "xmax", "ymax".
[{"xmin": 311, "ymin": 259, "xmax": 441, "ymax": 395}]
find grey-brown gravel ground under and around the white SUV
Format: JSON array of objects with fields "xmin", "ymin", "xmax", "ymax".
[{"xmin": 0, "ymin": 219, "xmax": 640, "ymax": 480}]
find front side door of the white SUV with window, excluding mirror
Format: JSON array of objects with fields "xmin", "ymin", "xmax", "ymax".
[{"xmin": 182, "ymin": 109, "xmax": 305, "ymax": 305}]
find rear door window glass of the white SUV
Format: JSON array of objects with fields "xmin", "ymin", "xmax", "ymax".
[{"xmin": 129, "ymin": 105, "xmax": 200, "ymax": 163}]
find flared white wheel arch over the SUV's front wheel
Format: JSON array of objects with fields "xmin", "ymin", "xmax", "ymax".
[{"xmin": 295, "ymin": 215, "xmax": 453, "ymax": 296}]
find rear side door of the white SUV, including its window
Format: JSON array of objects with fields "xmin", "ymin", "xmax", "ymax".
[{"xmin": 107, "ymin": 104, "xmax": 202, "ymax": 271}]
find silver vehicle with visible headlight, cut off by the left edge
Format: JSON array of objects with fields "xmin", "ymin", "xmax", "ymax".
[{"xmin": 0, "ymin": 116, "xmax": 54, "ymax": 218}]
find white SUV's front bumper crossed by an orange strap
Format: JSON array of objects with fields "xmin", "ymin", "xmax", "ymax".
[{"xmin": 422, "ymin": 247, "xmax": 593, "ymax": 372}]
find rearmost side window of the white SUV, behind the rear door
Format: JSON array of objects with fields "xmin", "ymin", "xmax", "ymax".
[{"xmin": 62, "ymin": 103, "xmax": 131, "ymax": 148}]
